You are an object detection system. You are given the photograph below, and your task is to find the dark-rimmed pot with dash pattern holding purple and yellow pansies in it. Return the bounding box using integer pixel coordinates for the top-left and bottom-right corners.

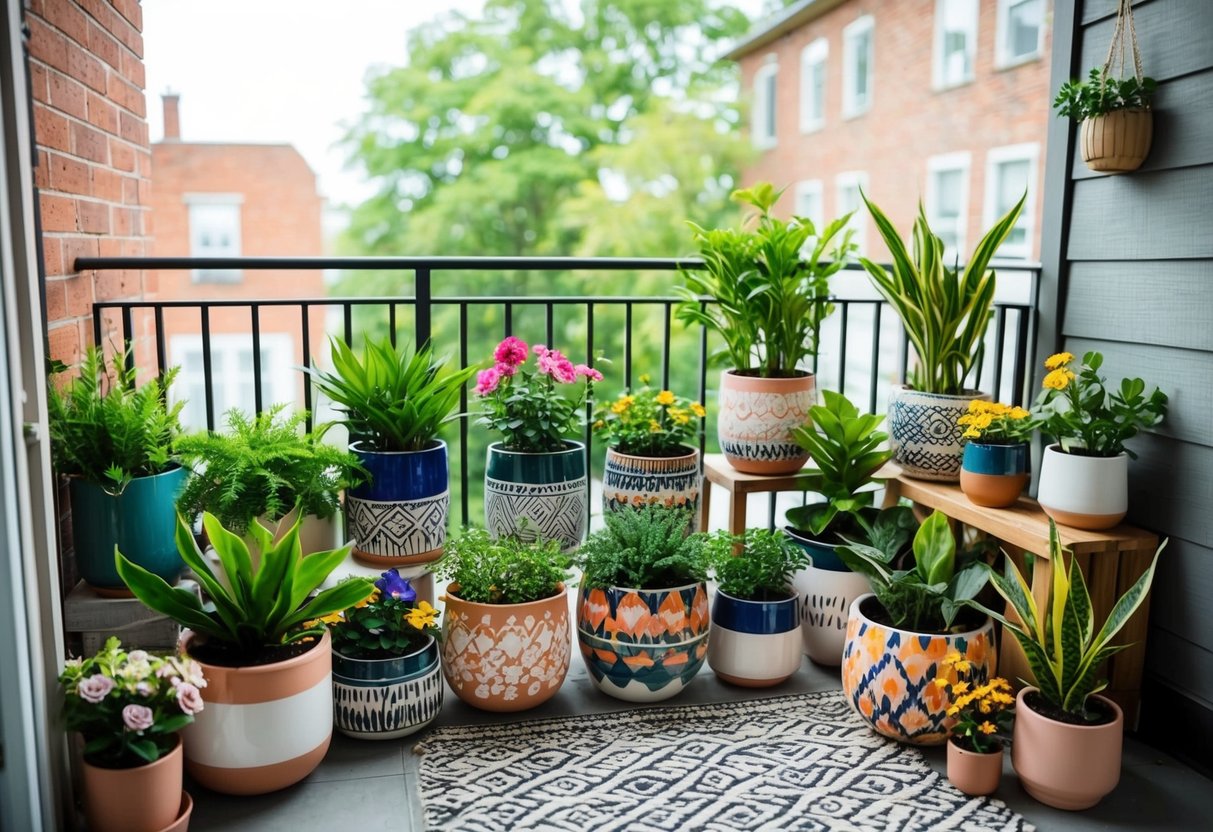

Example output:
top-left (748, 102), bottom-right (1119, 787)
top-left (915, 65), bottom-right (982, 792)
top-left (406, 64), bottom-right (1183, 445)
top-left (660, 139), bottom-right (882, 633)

top-left (332, 638), bottom-right (445, 740)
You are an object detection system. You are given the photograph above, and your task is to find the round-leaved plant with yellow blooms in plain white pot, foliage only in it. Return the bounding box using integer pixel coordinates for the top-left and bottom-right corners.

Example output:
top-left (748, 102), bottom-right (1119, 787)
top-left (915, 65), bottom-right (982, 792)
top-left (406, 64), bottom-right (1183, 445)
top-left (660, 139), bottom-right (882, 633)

top-left (1032, 352), bottom-right (1167, 460)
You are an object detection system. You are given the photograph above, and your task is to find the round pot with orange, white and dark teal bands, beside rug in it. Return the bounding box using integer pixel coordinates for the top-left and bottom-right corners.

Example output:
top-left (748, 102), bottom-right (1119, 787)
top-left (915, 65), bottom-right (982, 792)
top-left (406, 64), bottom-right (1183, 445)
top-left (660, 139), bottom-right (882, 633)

top-left (577, 582), bottom-right (711, 702)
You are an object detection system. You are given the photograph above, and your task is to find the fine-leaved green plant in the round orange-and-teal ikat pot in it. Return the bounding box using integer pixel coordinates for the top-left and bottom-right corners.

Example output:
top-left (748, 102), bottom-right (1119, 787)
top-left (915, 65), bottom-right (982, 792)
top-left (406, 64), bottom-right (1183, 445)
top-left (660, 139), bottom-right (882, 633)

top-left (576, 503), bottom-right (707, 589)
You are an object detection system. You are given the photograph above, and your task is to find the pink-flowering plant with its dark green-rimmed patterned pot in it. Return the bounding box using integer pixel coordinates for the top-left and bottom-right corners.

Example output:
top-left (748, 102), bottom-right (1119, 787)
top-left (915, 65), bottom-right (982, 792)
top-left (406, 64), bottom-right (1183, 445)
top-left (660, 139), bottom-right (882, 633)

top-left (475, 336), bottom-right (603, 552)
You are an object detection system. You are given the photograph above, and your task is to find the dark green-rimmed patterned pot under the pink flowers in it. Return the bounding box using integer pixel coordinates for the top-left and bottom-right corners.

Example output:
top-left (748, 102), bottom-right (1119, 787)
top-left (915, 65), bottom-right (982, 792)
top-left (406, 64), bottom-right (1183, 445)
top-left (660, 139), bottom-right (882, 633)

top-left (484, 440), bottom-right (590, 552)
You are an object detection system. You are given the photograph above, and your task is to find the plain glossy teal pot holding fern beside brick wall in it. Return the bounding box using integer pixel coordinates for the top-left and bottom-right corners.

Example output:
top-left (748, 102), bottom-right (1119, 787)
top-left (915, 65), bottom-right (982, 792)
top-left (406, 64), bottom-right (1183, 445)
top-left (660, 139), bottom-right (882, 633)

top-left (68, 466), bottom-right (188, 597)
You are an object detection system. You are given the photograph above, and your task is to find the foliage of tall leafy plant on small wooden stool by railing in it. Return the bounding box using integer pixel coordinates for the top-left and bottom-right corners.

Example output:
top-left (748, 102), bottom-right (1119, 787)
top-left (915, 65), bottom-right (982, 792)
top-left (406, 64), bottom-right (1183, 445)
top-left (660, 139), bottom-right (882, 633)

top-left (678, 182), bottom-right (855, 378)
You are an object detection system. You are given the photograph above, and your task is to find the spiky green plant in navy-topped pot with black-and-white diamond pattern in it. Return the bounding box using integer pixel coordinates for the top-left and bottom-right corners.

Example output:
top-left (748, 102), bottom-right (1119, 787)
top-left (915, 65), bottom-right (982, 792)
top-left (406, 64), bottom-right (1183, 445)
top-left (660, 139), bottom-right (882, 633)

top-left (307, 337), bottom-right (475, 571)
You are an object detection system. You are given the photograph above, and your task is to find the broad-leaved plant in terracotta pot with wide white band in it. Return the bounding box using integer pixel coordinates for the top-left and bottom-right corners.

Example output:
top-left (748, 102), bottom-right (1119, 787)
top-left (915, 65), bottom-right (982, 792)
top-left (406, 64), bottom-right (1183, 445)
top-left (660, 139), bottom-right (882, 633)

top-left (114, 513), bottom-right (374, 794)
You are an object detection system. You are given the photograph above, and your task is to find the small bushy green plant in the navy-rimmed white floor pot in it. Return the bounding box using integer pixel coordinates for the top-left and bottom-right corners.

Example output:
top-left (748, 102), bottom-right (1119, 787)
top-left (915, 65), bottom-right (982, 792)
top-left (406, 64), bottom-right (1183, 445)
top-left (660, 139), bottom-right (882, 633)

top-left (704, 529), bottom-right (809, 600)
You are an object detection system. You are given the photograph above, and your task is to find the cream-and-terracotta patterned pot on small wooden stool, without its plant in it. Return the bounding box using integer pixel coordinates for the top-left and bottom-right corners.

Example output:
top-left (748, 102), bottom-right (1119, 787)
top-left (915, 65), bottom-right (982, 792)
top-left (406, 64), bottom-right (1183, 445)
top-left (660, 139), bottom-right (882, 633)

top-left (717, 370), bottom-right (818, 474)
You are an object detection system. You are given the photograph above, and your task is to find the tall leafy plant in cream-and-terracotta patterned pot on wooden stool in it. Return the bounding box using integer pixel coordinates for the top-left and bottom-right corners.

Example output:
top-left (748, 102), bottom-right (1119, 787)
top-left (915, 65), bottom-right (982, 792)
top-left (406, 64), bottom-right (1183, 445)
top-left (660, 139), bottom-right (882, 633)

top-left (678, 182), bottom-right (855, 474)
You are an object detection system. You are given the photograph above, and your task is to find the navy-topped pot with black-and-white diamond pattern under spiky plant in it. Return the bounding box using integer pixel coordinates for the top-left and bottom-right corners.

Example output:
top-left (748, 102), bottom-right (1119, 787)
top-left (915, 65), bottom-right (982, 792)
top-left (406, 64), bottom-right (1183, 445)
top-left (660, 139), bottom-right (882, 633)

top-left (346, 440), bottom-right (450, 568)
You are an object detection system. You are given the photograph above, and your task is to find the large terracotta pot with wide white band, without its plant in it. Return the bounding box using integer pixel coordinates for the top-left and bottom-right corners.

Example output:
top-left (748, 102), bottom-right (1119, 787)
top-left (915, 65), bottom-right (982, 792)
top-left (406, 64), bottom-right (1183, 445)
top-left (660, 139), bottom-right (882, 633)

top-left (182, 631), bottom-right (332, 794)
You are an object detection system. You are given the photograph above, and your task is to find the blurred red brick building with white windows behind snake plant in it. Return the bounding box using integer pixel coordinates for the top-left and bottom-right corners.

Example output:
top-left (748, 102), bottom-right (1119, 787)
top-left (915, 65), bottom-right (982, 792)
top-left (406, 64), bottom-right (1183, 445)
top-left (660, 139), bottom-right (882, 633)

top-left (728, 0), bottom-right (1053, 261)
